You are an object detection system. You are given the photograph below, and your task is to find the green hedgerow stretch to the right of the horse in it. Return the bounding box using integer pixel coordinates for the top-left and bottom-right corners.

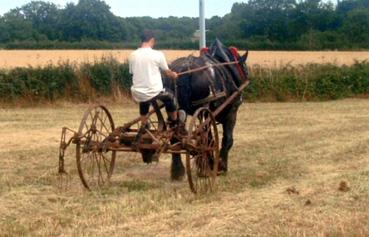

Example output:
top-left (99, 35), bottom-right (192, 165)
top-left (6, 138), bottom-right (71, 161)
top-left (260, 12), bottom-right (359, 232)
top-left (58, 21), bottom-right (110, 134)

top-left (244, 62), bottom-right (369, 101)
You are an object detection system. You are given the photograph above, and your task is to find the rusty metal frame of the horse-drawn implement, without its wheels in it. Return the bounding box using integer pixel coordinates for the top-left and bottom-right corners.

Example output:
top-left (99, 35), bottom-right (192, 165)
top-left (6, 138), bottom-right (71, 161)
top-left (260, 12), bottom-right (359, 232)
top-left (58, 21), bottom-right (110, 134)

top-left (58, 57), bottom-right (249, 193)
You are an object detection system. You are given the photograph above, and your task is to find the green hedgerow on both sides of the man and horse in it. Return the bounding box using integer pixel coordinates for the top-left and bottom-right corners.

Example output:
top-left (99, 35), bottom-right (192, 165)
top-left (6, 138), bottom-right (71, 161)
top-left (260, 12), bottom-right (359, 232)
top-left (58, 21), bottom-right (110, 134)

top-left (0, 58), bottom-right (369, 103)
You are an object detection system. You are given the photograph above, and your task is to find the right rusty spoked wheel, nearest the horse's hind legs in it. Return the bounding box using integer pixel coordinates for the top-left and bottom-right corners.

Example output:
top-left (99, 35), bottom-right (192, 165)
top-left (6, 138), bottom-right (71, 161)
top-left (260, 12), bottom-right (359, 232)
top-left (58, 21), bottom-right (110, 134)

top-left (186, 108), bottom-right (219, 193)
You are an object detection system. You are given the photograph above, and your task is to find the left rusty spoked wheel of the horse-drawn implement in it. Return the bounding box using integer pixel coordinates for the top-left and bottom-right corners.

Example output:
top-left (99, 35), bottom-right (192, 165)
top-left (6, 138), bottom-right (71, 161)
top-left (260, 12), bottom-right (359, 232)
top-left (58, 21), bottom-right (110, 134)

top-left (76, 106), bottom-right (116, 191)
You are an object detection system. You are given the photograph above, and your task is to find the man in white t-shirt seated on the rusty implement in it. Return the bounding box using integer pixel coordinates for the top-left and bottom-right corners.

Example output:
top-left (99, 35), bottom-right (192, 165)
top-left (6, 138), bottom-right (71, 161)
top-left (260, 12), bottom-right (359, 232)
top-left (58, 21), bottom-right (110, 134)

top-left (129, 30), bottom-right (178, 128)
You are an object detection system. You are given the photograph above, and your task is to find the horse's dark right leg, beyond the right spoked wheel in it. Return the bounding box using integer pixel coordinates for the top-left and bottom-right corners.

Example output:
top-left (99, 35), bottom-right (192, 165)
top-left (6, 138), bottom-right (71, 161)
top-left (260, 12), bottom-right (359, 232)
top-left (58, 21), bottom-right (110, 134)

top-left (220, 105), bottom-right (239, 173)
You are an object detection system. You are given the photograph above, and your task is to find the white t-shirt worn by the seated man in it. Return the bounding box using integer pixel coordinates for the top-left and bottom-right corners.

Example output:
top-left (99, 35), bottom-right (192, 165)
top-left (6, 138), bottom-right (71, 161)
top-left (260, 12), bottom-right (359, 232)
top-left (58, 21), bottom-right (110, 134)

top-left (129, 48), bottom-right (169, 102)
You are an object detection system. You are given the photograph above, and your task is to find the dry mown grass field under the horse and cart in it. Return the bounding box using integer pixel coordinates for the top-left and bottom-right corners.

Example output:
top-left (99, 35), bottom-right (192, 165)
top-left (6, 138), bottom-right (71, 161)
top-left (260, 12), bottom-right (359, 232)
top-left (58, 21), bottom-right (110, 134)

top-left (0, 100), bottom-right (369, 236)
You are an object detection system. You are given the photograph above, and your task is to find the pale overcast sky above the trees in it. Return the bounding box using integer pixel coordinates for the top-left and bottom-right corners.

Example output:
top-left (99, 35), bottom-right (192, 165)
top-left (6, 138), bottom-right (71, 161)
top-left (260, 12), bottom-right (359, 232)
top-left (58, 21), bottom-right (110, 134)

top-left (0, 0), bottom-right (246, 18)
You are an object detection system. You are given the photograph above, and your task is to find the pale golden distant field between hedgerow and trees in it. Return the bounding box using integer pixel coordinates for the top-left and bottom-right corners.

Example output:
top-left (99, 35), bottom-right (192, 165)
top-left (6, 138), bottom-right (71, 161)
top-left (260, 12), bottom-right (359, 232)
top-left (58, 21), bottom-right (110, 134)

top-left (0, 50), bottom-right (369, 68)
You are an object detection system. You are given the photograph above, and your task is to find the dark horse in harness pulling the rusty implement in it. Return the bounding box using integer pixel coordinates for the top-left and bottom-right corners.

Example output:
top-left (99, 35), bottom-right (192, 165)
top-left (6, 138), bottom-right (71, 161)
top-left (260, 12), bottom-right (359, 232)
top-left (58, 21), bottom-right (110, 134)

top-left (163, 39), bottom-right (249, 180)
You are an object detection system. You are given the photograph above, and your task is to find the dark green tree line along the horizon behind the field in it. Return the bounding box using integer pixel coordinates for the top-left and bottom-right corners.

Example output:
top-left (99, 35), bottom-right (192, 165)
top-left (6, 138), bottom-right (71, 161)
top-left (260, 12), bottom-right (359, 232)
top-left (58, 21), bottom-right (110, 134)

top-left (0, 0), bottom-right (369, 50)
